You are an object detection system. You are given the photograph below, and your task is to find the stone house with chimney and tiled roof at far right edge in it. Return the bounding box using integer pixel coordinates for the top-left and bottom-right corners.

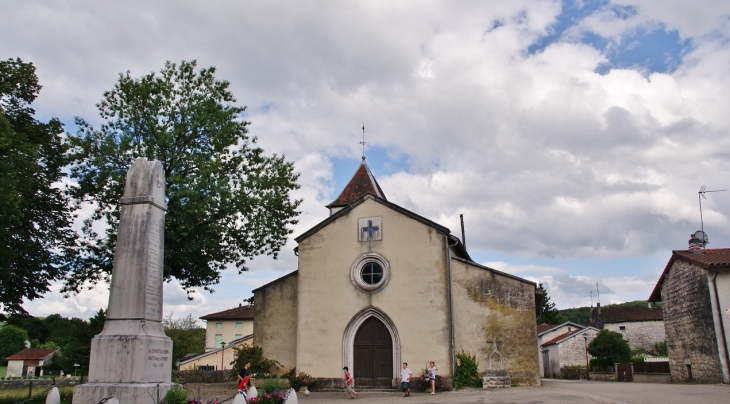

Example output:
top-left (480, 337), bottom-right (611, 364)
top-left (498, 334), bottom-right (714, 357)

top-left (649, 246), bottom-right (730, 383)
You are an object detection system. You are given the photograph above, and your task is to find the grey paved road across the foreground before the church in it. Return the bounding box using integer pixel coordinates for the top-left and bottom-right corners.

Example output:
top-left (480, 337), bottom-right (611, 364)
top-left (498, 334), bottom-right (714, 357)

top-left (286, 380), bottom-right (730, 404)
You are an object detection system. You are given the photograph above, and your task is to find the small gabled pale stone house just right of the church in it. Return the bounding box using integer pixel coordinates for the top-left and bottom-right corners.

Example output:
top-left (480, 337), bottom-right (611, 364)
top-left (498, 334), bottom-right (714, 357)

top-left (540, 323), bottom-right (599, 378)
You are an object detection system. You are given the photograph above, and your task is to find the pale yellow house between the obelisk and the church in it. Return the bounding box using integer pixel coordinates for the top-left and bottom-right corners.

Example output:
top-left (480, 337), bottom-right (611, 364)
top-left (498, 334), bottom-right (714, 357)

top-left (200, 304), bottom-right (254, 352)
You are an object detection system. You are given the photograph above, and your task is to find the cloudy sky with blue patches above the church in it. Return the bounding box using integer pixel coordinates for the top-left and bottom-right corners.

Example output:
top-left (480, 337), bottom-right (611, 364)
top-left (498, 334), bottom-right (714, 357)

top-left (0, 0), bottom-right (730, 318)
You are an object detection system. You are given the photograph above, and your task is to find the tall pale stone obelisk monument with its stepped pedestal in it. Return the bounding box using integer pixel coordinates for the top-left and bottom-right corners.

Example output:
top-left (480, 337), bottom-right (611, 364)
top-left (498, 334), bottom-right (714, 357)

top-left (73, 158), bottom-right (172, 404)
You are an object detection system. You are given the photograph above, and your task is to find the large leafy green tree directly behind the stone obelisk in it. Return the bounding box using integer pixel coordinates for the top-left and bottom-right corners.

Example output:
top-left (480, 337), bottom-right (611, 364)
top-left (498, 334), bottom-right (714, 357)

top-left (64, 61), bottom-right (301, 292)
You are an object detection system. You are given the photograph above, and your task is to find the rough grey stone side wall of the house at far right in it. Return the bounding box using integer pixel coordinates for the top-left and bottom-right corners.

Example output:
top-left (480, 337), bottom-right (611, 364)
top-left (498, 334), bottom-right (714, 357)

top-left (662, 260), bottom-right (721, 383)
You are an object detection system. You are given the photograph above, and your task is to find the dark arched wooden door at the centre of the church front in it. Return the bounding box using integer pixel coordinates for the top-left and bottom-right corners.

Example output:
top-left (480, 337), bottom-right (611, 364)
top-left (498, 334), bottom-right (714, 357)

top-left (353, 317), bottom-right (393, 387)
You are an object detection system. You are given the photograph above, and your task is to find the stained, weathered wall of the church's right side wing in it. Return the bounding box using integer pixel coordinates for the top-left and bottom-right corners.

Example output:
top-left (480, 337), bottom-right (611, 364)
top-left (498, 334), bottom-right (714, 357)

top-left (452, 258), bottom-right (540, 386)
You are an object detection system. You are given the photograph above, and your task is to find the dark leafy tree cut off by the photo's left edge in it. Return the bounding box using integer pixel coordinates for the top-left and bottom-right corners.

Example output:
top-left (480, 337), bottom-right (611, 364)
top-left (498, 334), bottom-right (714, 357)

top-left (0, 59), bottom-right (76, 313)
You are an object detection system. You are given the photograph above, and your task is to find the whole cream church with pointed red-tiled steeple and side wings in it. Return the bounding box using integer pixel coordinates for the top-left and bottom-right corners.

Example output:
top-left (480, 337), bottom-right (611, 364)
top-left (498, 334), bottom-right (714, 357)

top-left (254, 159), bottom-right (542, 388)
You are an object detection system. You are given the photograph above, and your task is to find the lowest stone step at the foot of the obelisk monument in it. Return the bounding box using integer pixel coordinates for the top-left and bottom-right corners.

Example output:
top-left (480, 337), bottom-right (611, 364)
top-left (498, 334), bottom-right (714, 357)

top-left (73, 383), bottom-right (175, 404)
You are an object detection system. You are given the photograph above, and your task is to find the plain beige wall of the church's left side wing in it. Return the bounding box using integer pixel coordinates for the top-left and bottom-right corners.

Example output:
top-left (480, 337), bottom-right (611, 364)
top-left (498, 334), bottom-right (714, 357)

top-left (253, 274), bottom-right (298, 373)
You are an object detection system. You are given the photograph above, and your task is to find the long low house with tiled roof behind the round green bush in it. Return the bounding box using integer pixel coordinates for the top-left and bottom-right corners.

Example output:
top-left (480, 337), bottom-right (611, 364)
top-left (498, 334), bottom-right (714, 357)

top-left (591, 303), bottom-right (666, 352)
